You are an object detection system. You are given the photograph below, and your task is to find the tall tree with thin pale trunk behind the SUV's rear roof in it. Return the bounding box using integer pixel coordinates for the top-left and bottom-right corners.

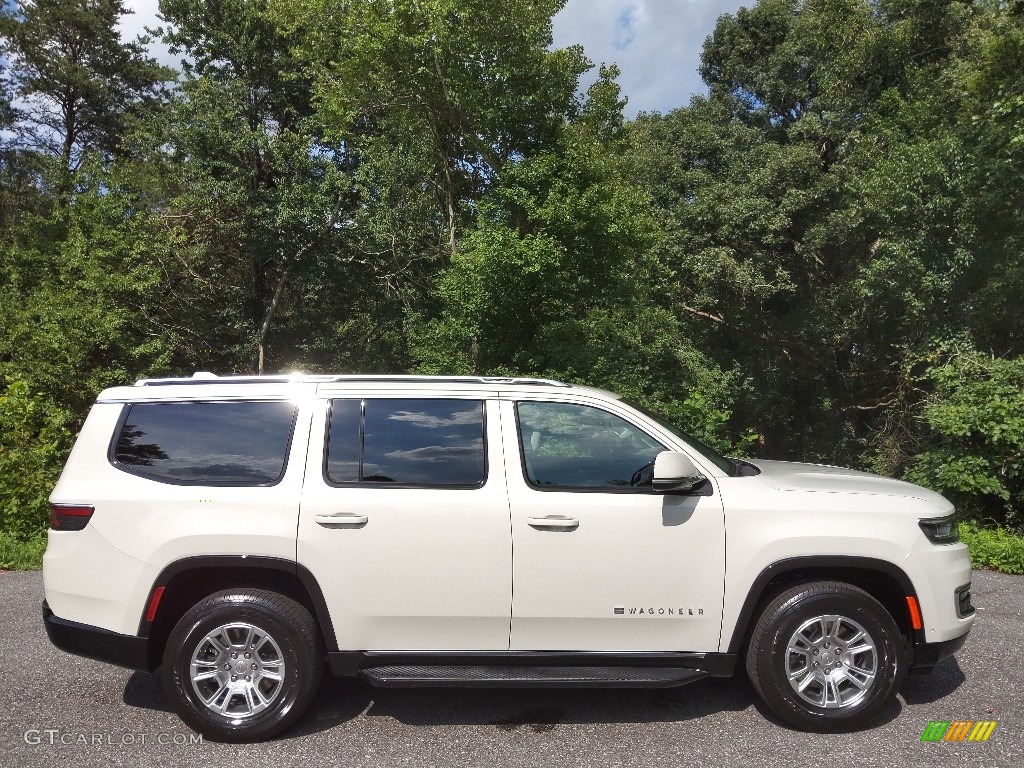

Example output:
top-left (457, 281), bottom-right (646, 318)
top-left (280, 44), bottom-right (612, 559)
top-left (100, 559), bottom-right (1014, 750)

top-left (147, 0), bottom-right (400, 373)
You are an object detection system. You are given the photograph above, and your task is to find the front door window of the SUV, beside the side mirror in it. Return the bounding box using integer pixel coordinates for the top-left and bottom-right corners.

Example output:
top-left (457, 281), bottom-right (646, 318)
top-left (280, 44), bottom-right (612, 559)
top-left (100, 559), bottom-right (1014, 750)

top-left (516, 401), bottom-right (666, 490)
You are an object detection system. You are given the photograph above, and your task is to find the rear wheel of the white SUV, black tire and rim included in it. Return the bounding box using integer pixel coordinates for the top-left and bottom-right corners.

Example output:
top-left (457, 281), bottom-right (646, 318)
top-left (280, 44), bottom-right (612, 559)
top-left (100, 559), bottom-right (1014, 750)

top-left (162, 589), bottom-right (324, 741)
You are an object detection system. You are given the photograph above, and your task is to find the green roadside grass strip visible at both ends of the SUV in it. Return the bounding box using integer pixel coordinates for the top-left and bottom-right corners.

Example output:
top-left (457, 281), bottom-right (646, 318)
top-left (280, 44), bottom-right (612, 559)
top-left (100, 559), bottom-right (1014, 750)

top-left (0, 522), bottom-right (1024, 573)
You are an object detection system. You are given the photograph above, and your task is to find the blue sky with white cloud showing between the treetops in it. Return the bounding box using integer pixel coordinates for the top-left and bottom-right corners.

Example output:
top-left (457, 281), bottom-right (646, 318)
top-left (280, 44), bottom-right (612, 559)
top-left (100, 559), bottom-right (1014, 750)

top-left (122, 0), bottom-right (754, 118)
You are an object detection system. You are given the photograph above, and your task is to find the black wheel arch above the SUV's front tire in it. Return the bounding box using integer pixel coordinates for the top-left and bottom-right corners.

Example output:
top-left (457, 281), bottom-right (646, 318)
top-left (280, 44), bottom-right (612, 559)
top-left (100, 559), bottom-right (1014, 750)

top-left (728, 555), bottom-right (925, 653)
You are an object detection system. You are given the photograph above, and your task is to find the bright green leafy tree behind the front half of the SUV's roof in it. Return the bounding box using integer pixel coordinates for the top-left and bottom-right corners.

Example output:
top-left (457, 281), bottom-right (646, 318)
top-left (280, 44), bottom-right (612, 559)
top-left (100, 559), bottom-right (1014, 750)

top-left (413, 69), bottom-right (736, 446)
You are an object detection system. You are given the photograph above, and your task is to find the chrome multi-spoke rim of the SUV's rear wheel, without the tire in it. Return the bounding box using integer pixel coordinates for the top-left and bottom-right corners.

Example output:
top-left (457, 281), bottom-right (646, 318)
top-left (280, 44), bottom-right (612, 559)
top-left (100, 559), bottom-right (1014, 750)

top-left (188, 622), bottom-right (285, 720)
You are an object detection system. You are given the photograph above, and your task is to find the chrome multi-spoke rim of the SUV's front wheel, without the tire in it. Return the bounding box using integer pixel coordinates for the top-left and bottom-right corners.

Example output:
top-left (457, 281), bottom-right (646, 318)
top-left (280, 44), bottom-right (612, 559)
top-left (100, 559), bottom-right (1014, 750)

top-left (785, 614), bottom-right (879, 710)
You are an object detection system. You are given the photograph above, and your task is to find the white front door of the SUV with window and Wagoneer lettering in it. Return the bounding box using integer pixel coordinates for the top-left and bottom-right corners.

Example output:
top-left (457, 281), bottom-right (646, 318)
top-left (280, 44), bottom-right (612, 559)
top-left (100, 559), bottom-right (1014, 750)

top-left (501, 397), bottom-right (725, 651)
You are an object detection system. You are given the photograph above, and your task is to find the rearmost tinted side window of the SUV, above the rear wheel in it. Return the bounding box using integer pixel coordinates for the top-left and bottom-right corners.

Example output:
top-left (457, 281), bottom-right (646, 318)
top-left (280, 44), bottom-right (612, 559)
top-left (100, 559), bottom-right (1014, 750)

top-left (111, 401), bottom-right (296, 486)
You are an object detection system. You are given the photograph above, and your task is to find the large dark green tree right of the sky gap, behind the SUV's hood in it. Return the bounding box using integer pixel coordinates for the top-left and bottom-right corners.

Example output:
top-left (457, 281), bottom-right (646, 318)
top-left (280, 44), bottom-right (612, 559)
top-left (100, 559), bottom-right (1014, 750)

top-left (632, 0), bottom-right (976, 462)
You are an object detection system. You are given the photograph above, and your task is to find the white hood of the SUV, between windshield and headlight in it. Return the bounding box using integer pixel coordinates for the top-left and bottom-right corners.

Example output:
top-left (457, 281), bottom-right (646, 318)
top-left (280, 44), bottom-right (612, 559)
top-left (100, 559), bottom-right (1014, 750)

top-left (744, 459), bottom-right (952, 510)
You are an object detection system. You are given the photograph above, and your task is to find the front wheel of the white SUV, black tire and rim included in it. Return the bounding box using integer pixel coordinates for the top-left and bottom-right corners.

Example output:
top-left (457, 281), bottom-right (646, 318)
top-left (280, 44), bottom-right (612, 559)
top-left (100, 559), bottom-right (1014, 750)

top-left (746, 582), bottom-right (906, 732)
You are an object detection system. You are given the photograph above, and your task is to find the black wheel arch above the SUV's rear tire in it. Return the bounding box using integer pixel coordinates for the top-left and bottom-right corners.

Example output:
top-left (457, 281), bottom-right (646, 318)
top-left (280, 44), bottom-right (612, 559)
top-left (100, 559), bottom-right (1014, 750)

top-left (138, 555), bottom-right (338, 671)
